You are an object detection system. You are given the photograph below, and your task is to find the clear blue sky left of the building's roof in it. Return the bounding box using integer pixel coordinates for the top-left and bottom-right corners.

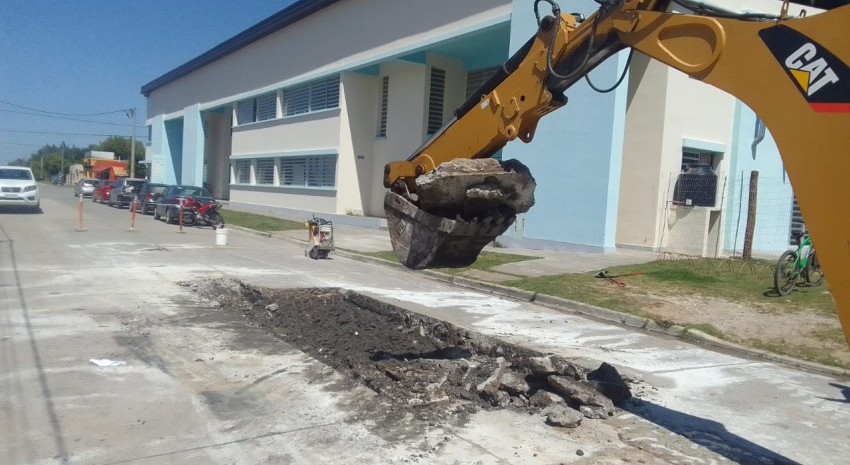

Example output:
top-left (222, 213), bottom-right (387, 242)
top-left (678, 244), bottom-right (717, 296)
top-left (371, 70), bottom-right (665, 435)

top-left (0, 0), bottom-right (294, 164)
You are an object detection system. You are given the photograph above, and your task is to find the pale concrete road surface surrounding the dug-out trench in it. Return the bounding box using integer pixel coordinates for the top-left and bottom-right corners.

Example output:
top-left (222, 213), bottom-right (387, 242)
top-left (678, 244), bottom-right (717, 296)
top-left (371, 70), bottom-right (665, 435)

top-left (0, 186), bottom-right (850, 465)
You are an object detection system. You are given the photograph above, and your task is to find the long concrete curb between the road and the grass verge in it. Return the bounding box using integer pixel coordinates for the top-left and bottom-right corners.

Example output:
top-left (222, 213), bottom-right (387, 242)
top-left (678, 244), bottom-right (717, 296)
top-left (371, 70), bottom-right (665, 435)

top-left (229, 226), bottom-right (850, 377)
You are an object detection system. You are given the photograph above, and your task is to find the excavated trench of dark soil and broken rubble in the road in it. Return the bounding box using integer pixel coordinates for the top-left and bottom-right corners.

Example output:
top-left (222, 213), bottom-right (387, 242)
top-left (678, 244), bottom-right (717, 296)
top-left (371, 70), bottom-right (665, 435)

top-left (182, 279), bottom-right (631, 427)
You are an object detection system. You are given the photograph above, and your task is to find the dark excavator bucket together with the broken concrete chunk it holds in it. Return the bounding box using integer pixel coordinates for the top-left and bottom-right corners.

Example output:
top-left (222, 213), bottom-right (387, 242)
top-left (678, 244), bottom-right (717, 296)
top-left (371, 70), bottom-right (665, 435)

top-left (384, 158), bottom-right (536, 269)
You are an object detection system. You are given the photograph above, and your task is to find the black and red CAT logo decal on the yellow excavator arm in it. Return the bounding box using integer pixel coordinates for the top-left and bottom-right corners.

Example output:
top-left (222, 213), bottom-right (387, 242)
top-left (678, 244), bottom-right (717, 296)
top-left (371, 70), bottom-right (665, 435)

top-left (759, 25), bottom-right (850, 113)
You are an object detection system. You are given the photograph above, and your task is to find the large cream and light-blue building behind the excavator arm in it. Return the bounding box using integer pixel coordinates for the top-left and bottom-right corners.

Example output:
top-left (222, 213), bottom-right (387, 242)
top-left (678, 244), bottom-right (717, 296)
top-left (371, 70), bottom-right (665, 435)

top-left (141, 0), bottom-right (811, 256)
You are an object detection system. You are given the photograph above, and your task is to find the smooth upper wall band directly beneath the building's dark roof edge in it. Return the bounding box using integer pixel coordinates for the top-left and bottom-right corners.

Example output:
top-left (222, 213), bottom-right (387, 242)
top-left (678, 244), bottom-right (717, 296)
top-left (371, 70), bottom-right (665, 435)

top-left (147, 0), bottom-right (510, 115)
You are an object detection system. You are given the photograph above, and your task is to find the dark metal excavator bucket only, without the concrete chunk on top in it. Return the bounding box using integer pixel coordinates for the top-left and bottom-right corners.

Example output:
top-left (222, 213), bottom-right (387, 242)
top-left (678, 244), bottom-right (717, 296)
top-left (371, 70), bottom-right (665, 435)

top-left (384, 192), bottom-right (516, 270)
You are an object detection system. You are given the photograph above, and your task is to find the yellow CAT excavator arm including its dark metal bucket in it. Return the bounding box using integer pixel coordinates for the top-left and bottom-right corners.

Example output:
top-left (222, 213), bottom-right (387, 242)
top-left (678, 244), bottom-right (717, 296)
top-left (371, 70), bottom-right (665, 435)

top-left (384, 0), bottom-right (850, 342)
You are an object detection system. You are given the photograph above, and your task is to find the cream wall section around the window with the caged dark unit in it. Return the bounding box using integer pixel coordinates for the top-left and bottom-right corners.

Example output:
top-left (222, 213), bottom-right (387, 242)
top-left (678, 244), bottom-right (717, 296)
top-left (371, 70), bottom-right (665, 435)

top-left (617, 0), bottom-right (817, 255)
